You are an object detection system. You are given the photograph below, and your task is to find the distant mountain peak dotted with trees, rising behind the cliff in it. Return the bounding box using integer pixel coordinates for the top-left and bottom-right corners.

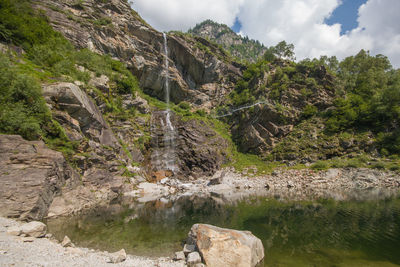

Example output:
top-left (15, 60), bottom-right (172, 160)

top-left (188, 20), bottom-right (267, 63)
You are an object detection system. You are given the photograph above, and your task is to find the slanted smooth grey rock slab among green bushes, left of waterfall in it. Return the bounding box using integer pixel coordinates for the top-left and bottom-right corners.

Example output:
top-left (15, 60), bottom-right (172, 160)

top-left (43, 83), bottom-right (119, 147)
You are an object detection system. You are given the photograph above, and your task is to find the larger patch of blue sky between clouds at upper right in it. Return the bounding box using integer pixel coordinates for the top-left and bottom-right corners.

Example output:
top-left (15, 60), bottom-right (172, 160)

top-left (325, 0), bottom-right (367, 35)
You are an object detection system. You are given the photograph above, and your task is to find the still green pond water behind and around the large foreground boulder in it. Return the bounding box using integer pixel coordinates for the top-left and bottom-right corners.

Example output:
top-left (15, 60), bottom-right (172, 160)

top-left (48, 196), bottom-right (400, 266)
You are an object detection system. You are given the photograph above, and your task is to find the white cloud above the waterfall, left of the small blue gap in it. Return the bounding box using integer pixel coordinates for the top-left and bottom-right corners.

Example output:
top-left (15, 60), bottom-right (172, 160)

top-left (132, 0), bottom-right (245, 31)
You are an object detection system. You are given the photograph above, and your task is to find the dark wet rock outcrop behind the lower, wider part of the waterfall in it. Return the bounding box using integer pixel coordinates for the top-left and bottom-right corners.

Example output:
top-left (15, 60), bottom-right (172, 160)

top-left (149, 111), bottom-right (229, 180)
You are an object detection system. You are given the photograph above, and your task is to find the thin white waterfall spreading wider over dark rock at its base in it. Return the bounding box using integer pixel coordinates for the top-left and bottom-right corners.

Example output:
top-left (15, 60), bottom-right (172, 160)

top-left (151, 33), bottom-right (178, 174)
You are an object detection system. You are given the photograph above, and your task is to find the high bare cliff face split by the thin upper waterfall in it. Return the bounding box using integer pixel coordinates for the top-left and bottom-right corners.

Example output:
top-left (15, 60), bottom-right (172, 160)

top-left (34, 0), bottom-right (241, 107)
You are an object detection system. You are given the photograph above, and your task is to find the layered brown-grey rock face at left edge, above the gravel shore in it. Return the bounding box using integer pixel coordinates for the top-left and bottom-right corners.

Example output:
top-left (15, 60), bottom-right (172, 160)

top-left (0, 135), bottom-right (79, 220)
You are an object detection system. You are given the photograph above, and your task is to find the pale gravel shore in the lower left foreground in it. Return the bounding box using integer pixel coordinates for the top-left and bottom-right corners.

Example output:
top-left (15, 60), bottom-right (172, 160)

top-left (0, 217), bottom-right (185, 267)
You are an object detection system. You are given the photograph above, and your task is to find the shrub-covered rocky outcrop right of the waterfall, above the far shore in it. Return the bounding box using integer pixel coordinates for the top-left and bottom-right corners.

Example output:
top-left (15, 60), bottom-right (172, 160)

top-left (230, 63), bottom-right (335, 156)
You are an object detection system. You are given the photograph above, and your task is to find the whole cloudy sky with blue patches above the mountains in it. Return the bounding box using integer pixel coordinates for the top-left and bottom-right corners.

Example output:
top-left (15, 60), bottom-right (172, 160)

top-left (132, 0), bottom-right (400, 68)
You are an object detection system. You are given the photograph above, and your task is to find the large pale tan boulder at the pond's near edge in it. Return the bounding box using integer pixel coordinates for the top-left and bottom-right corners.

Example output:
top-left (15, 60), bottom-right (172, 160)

top-left (188, 224), bottom-right (264, 267)
